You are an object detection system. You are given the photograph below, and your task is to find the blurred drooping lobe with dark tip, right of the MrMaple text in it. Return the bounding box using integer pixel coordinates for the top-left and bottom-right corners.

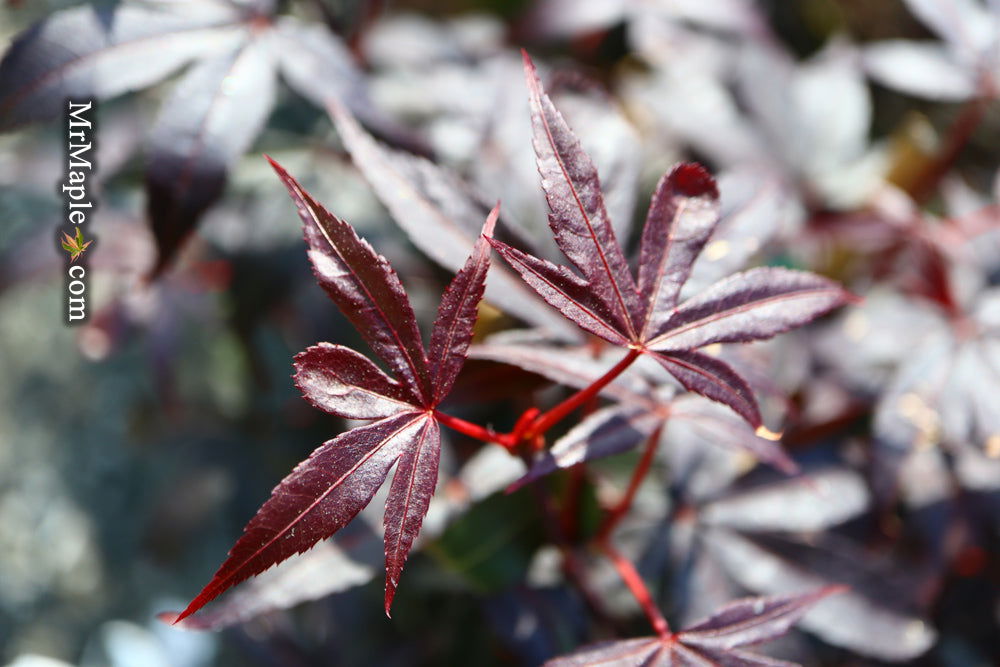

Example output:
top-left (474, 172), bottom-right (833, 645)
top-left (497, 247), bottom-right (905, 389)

top-left (146, 38), bottom-right (275, 275)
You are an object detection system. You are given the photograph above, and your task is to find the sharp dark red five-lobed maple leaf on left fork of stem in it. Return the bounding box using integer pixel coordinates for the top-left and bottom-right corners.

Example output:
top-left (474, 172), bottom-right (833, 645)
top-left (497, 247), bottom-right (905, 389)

top-left (175, 160), bottom-right (499, 622)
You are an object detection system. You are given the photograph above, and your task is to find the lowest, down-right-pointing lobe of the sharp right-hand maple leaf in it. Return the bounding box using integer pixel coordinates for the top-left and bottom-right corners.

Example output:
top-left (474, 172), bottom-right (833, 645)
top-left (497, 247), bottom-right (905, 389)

top-left (650, 351), bottom-right (762, 428)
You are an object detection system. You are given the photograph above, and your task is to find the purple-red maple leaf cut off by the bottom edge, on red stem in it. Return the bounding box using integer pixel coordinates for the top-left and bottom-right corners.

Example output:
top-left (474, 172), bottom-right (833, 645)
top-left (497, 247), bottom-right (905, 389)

top-left (545, 586), bottom-right (844, 667)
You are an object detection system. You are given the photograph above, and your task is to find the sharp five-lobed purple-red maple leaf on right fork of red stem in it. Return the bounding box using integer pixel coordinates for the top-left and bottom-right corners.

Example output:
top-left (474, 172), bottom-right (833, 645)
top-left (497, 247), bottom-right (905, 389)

top-left (490, 53), bottom-right (849, 428)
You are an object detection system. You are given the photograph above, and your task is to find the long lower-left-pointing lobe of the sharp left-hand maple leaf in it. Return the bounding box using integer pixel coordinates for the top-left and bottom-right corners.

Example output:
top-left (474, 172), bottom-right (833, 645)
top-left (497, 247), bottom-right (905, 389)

top-left (176, 412), bottom-right (427, 621)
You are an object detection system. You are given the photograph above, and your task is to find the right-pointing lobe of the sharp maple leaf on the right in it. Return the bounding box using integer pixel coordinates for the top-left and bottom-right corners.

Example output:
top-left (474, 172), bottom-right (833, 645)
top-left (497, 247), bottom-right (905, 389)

top-left (648, 267), bottom-right (850, 351)
